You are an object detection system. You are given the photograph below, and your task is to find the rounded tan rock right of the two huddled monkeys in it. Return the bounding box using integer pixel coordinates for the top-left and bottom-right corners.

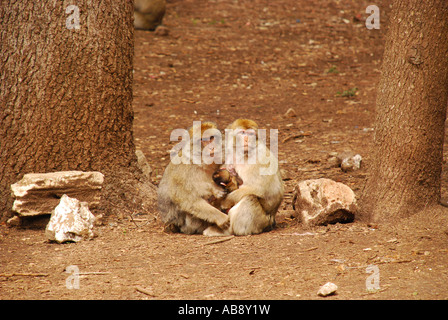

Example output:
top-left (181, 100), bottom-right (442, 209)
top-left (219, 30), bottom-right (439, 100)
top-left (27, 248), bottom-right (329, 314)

top-left (292, 178), bottom-right (357, 226)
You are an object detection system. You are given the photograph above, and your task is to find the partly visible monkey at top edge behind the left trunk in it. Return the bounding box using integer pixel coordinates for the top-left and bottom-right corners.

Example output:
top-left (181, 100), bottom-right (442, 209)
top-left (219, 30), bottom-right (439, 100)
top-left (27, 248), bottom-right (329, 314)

top-left (134, 0), bottom-right (166, 31)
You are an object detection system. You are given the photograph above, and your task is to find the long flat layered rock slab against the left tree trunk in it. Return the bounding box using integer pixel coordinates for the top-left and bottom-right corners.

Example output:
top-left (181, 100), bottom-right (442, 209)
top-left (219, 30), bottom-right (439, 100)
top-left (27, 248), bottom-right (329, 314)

top-left (11, 171), bottom-right (104, 216)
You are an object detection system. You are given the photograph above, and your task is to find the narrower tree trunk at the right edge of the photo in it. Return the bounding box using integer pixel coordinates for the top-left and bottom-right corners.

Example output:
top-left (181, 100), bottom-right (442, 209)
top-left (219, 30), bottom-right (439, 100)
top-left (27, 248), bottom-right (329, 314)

top-left (360, 0), bottom-right (448, 222)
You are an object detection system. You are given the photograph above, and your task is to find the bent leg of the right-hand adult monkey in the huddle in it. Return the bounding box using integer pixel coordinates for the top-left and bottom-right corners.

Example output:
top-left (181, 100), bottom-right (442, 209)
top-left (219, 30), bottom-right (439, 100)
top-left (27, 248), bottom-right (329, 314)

top-left (229, 195), bottom-right (274, 236)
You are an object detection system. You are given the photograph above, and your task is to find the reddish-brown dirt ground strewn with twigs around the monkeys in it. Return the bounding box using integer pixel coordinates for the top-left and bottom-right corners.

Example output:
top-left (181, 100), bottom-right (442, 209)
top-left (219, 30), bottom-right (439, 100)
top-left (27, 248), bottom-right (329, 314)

top-left (0, 0), bottom-right (448, 300)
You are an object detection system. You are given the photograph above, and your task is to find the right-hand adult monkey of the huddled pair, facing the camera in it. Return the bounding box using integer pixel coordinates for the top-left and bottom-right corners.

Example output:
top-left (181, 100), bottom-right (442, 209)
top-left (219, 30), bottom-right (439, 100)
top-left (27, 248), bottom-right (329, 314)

top-left (206, 119), bottom-right (284, 236)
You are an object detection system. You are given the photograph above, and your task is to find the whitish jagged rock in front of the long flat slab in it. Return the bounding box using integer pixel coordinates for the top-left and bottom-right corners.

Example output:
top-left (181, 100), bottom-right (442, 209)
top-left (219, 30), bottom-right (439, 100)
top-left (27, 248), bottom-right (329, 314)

top-left (45, 194), bottom-right (95, 243)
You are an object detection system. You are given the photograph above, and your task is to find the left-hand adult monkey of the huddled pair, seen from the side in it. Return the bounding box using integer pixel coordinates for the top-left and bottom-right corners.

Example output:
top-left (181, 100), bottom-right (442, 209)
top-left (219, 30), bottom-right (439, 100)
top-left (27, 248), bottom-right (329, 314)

top-left (157, 122), bottom-right (229, 234)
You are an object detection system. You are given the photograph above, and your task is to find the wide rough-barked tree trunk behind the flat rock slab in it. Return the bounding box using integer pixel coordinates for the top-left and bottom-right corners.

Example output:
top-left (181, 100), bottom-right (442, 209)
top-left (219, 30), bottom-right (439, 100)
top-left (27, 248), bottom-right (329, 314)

top-left (0, 0), bottom-right (158, 220)
